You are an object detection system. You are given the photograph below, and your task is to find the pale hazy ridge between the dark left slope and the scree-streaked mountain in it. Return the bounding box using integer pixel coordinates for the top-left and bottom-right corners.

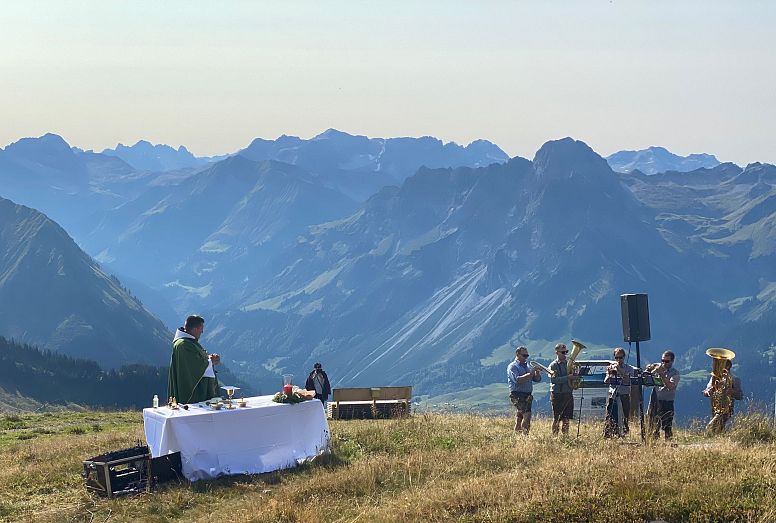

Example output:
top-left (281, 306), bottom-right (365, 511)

top-left (84, 155), bottom-right (356, 314)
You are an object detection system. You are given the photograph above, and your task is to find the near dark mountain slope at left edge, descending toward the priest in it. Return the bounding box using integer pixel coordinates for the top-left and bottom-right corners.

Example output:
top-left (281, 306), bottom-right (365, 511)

top-left (0, 198), bottom-right (170, 367)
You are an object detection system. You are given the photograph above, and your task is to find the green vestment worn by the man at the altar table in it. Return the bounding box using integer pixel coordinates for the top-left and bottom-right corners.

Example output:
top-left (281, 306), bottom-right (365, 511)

top-left (167, 338), bottom-right (218, 403)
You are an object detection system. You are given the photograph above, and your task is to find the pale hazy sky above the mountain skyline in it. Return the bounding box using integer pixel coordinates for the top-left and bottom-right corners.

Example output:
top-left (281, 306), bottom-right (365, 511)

top-left (0, 0), bottom-right (776, 164)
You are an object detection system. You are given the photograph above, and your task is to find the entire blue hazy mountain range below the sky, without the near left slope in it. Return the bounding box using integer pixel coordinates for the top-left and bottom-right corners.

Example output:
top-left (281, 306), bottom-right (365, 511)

top-left (0, 130), bottom-right (776, 416)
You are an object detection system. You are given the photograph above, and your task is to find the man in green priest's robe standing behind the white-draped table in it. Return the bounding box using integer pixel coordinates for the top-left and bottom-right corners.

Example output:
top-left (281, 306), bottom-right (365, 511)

top-left (167, 315), bottom-right (221, 403)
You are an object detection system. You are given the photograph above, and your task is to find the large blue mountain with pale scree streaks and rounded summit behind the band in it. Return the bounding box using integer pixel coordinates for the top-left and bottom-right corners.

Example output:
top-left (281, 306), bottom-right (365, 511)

top-left (203, 139), bottom-right (744, 398)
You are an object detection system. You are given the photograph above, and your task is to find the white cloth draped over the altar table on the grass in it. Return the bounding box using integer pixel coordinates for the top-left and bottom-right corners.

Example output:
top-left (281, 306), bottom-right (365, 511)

top-left (143, 396), bottom-right (329, 481)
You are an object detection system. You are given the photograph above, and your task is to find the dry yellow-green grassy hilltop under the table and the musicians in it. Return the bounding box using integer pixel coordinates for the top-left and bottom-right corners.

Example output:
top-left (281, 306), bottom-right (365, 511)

top-left (0, 412), bottom-right (776, 522)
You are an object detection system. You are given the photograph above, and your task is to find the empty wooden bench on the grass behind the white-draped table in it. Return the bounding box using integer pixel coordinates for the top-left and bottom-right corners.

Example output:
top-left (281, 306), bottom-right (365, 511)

top-left (327, 387), bottom-right (412, 419)
